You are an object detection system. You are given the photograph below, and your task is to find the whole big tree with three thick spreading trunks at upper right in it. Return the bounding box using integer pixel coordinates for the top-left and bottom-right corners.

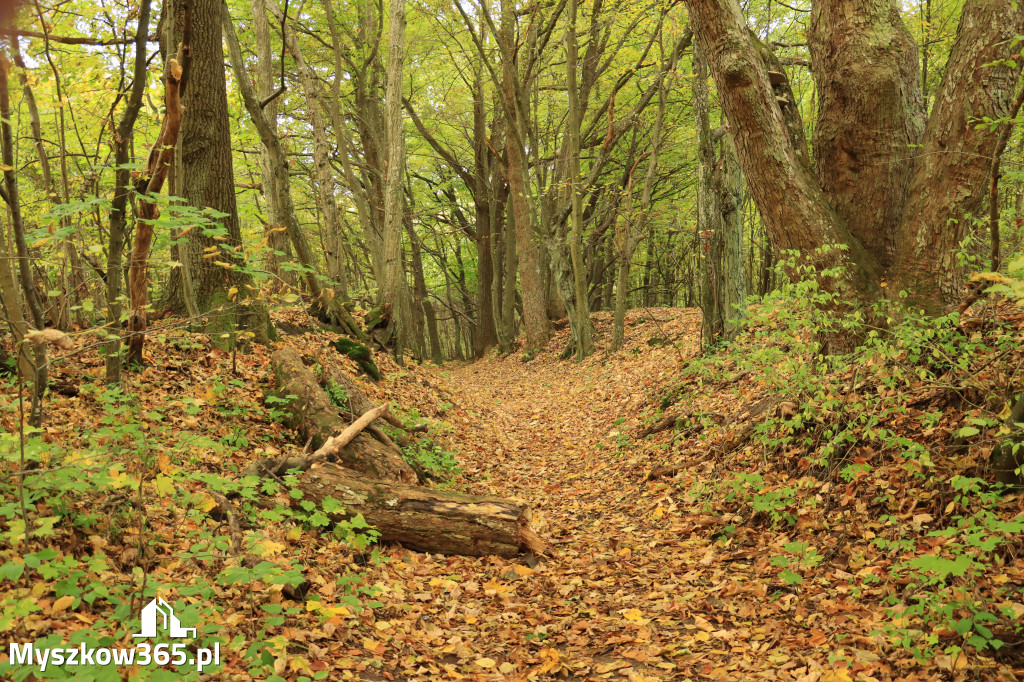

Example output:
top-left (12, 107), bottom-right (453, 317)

top-left (686, 0), bottom-right (1024, 311)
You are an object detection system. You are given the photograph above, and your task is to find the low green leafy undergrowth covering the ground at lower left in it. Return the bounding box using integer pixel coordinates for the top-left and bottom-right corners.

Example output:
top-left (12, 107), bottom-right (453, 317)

top-left (0, 348), bottom-right (378, 680)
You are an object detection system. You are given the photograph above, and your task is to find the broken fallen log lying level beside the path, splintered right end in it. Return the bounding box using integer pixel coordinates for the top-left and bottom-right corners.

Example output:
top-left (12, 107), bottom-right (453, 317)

top-left (294, 464), bottom-right (545, 558)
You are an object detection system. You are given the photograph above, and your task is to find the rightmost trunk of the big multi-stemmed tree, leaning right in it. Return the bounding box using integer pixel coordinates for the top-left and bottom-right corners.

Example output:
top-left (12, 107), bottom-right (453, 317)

top-left (892, 0), bottom-right (1024, 303)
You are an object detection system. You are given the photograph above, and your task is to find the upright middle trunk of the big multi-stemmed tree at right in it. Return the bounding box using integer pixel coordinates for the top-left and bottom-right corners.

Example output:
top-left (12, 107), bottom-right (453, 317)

top-left (807, 0), bottom-right (925, 267)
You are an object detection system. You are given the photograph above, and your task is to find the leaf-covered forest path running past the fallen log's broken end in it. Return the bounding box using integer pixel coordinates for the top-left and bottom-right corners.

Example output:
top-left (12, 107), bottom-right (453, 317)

top-left (419, 309), bottom-right (787, 680)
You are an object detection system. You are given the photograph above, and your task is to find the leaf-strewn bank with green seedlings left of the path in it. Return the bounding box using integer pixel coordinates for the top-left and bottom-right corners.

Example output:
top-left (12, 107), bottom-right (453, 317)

top-left (0, 310), bottom-right (464, 680)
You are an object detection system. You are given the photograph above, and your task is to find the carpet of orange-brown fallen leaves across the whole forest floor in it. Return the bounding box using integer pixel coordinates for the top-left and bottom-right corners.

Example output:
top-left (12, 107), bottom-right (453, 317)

top-left (0, 308), bottom-right (1024, 682)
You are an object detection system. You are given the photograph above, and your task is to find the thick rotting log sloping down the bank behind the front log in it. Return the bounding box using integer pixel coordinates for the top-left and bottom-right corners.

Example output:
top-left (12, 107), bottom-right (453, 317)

top-left (270, 348), bottom-right (418, 483)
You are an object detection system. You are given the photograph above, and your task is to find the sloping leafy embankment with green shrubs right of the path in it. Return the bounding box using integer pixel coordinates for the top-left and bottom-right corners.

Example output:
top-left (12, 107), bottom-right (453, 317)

top-left (638, 291), bottom-right (1024, 671)
